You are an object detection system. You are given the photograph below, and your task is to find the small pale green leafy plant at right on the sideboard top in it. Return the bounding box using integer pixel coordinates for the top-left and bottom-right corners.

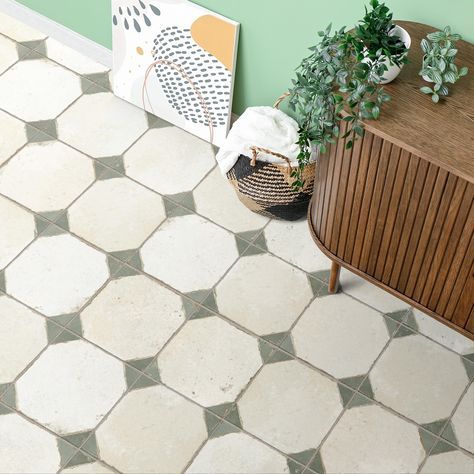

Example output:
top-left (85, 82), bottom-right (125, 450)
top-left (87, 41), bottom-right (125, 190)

top-left (420, 26), bottom-right (468, 103)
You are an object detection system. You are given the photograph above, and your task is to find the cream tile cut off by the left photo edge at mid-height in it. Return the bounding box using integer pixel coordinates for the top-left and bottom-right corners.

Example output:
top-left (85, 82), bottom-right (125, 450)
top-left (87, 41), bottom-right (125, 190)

top-left (0, 196), bottom-right (35, 269)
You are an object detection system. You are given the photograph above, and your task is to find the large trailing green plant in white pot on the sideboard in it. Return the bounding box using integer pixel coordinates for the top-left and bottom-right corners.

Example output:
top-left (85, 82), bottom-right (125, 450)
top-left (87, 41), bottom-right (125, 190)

top-left (289, 0), bottom-right (410, 188)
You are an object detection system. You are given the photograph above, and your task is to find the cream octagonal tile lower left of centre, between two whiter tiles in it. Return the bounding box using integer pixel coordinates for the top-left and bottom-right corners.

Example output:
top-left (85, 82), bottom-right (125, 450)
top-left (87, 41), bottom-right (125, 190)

top-left (81, 275), bottom-right (184, 360)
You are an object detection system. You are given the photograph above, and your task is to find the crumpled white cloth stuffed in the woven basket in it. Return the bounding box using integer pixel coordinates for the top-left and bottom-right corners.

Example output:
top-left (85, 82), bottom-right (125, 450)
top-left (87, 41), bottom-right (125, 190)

top-left (216, 107), bottom-right (299, 174)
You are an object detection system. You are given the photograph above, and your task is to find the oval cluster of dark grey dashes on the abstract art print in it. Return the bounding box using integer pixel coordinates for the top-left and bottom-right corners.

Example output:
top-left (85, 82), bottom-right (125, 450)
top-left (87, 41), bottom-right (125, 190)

top-left (153, 26), bottom-right (232, 127)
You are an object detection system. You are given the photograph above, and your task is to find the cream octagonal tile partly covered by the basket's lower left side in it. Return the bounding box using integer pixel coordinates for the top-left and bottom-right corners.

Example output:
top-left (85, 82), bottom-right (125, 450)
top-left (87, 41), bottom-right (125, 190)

top-left (193, 167), bottom-right (269, 232)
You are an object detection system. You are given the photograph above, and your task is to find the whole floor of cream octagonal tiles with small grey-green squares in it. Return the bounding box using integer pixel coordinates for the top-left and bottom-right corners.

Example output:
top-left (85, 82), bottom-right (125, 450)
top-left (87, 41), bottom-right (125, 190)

top-left (0, 15), bottom-right (474, 474)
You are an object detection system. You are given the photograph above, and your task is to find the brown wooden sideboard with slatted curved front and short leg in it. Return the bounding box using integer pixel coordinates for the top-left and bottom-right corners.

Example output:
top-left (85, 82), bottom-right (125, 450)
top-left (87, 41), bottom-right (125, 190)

top-left (308, 22), bottom-right (474, 339)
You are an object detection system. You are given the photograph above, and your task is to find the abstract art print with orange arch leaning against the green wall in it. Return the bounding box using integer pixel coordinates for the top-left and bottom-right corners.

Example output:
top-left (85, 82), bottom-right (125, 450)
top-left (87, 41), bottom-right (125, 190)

top-left (112, 0), bottom-right (239, 146)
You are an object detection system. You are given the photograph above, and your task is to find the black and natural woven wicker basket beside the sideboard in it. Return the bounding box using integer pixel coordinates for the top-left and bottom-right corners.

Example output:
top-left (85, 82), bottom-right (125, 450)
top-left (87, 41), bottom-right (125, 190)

top-left (227, 94), bottom-right (316, 221)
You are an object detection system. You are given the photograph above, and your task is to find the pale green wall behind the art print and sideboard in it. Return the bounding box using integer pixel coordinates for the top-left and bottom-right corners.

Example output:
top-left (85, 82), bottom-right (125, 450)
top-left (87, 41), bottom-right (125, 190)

top-left (14, 0), bottom-right (474, 113)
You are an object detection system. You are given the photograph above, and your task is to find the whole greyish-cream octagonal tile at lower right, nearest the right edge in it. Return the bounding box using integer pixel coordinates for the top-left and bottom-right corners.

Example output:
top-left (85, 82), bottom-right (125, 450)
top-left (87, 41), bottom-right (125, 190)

top-left (370, 335), bottom-right (469, 423)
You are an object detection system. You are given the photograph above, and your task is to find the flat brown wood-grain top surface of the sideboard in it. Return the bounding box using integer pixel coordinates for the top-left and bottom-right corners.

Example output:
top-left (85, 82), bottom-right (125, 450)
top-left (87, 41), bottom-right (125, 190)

top-left (366, 21), bottom-right (474, 183)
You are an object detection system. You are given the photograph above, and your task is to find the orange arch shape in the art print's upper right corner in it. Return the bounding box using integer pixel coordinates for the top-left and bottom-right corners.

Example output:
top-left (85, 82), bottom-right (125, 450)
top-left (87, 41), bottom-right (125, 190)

top-left (191, 15), bottom-right (236, 71)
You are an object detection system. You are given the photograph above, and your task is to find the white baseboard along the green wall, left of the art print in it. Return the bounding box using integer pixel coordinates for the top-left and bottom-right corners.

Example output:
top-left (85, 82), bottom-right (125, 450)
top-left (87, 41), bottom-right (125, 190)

top-left (0, 0), bottom-right (112, 68)
